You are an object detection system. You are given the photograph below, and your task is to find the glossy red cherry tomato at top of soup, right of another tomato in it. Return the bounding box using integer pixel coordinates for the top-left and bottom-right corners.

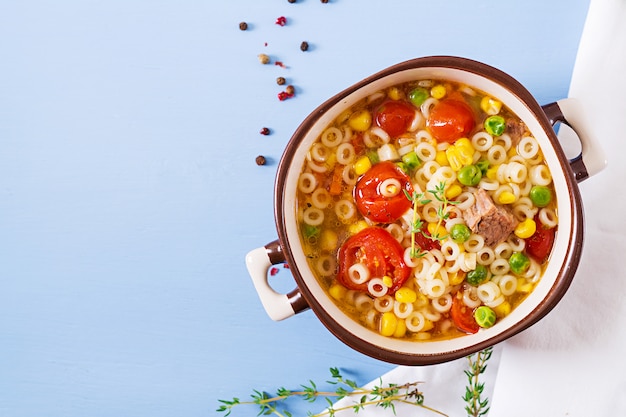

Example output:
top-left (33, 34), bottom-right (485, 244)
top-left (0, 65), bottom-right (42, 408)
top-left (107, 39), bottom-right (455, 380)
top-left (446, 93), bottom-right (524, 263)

top-left (426, 99), bottom-right (476, 143)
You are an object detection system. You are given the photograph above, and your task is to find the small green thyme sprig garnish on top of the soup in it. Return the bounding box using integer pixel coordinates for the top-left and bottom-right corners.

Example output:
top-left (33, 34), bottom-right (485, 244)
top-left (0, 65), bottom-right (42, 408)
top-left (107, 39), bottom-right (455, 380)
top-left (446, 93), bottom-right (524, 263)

top-left (403, 181), bottom-right (458, 258)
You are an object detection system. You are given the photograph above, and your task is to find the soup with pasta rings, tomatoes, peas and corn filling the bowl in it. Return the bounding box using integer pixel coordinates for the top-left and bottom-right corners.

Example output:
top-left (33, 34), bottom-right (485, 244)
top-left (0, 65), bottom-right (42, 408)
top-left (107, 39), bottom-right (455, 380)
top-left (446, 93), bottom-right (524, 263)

top-left (297, 80), bottom-right (558, 341)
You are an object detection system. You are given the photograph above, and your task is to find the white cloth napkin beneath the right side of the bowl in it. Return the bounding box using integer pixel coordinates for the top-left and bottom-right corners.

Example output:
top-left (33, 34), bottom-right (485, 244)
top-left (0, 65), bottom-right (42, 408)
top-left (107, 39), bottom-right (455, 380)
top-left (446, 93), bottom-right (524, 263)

top-left (490, 0), bottom-right (626, 417)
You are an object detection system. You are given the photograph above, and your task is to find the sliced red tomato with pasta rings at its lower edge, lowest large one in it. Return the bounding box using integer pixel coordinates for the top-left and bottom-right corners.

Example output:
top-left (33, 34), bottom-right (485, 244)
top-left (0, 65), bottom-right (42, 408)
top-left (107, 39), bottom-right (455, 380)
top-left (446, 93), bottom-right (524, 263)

top-left (337, 227), bottom-right (411, 294)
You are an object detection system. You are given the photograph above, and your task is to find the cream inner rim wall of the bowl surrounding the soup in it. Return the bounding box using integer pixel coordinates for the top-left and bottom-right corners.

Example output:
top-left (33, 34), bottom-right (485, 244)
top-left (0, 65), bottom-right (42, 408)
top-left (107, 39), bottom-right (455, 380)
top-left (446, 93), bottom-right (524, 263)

top-left (282, 67), bottom-right (573, 355)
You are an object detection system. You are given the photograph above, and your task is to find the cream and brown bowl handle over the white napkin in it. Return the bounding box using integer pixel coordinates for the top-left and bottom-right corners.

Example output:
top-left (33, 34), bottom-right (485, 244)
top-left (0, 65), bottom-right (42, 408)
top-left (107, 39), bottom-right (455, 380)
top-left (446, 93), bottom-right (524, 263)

top-left (542, 98), bottom-right (606, 182)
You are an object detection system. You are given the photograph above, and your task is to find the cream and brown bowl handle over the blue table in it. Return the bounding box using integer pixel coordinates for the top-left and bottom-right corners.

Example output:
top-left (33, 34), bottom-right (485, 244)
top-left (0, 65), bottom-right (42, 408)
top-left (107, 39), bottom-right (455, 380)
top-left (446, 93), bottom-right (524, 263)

top-left (246, 240), bottom-right (309, 321)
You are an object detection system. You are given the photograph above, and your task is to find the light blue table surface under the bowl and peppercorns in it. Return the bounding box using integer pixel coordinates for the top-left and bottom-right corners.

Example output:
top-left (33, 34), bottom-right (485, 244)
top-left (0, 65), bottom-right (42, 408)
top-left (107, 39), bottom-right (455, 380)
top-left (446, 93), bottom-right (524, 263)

top-left (0, 0), bottom-right (589, 417)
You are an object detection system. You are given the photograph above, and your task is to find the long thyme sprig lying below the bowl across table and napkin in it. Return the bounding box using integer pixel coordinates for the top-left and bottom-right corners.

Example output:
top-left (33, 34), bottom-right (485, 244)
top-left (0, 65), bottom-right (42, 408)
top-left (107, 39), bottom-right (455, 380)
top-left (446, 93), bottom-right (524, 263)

top-left (217, 368), bottom-right (446, 417)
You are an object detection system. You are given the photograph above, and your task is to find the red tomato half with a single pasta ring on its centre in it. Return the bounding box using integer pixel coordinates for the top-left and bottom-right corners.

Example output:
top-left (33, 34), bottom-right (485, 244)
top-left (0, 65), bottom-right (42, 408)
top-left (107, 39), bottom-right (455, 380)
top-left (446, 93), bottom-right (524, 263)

top-left (354, 161), bottom-right (413, 223)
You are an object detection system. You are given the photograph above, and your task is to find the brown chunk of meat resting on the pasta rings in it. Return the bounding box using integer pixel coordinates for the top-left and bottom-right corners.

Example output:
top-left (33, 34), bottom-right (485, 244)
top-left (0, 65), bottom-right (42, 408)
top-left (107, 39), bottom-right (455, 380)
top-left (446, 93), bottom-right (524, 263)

top-left (463, 188), bottom-right (518, 246)
